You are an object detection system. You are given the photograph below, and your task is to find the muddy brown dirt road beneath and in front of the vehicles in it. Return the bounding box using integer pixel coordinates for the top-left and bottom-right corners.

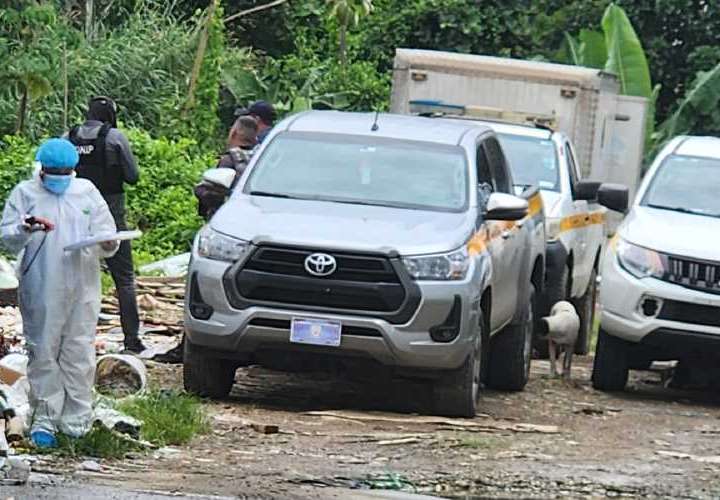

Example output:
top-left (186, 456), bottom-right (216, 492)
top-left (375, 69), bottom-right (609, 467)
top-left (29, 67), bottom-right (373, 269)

top-left (21, 358), bottom-right (720, 498)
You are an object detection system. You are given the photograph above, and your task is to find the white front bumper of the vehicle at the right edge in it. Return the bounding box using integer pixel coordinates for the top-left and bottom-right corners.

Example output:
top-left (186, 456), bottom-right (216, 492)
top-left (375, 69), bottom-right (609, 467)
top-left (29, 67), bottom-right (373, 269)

top-left (600, 251), bottom-right (720, 352)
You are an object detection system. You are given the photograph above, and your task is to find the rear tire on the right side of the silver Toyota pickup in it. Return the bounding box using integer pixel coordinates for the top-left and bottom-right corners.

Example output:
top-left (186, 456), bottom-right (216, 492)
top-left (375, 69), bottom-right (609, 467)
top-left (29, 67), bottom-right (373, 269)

top-left (488, 284), bottom-right (535, 391)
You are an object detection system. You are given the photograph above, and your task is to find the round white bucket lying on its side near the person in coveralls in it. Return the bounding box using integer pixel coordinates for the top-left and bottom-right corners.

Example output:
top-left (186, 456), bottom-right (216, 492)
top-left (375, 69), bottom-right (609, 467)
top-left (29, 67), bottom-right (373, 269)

top-left (95, 354), bottom-right (147, 398)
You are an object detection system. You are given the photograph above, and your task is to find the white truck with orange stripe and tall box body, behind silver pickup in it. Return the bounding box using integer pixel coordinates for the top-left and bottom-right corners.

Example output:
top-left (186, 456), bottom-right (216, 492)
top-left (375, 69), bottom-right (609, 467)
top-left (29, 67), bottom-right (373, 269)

top-left (391, 49), bottom-right (647, 356)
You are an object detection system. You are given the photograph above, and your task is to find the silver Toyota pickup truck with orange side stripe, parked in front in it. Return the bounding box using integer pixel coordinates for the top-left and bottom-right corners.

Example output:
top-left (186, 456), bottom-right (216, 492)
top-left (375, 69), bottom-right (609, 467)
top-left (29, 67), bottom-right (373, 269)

top-left (184, 111), bottom-right (544, 416)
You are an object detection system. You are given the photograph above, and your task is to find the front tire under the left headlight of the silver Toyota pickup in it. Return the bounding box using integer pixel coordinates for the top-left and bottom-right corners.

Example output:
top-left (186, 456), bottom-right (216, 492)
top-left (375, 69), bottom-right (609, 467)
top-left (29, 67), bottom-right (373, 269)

top-left (183, 338), bottom-right (237, 399)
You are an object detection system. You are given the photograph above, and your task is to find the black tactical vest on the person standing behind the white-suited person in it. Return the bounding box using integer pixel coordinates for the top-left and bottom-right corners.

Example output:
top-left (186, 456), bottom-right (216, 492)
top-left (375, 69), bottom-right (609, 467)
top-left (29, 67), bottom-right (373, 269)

top-left (69, 123), bottom-right (124, 195)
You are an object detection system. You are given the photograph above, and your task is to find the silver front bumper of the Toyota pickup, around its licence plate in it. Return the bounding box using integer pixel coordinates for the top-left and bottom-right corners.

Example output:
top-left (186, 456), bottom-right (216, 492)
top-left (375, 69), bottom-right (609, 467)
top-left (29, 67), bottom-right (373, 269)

top-left (185, 256), bottom-right (481, 370)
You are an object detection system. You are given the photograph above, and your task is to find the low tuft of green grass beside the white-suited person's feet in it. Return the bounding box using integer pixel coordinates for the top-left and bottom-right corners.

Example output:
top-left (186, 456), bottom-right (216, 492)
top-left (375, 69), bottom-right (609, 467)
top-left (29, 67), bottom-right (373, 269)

top-left (117, 390), bottom-right (206, 446)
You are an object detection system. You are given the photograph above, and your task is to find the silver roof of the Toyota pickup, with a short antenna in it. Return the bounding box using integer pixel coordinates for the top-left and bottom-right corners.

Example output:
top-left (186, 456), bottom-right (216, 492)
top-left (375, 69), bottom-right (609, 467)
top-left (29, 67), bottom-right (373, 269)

top-left (286, 111), bottom-right (490, 145)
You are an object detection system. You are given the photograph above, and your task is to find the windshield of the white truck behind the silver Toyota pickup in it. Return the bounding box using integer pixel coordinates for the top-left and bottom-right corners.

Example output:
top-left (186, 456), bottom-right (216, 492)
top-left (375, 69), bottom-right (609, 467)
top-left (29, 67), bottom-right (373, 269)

top-left (498, 134), bottom-right (560, 191)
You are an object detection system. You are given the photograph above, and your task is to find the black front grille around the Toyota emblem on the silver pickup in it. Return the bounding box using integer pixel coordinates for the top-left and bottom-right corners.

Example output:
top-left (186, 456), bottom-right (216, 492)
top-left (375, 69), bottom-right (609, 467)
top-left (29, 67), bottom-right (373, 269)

top-left (235, 246), bottom-right (407, 313)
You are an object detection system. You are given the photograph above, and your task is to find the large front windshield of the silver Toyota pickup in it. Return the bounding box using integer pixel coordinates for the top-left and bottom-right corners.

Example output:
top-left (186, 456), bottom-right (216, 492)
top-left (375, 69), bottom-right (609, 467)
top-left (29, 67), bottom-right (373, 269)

top-left (244, 133), bottom-right (468, 211)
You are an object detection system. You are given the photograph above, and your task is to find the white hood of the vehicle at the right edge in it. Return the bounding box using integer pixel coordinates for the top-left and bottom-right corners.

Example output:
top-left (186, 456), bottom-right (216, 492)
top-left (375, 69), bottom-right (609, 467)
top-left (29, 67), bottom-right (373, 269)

top-left (620, 206), bottom-right (720, 261)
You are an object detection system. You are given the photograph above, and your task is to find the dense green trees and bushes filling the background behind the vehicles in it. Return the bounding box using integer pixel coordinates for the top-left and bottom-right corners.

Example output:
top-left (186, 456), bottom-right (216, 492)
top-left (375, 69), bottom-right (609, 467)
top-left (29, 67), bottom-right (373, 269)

top-left (0, 0), bottom-right (720, 262)
